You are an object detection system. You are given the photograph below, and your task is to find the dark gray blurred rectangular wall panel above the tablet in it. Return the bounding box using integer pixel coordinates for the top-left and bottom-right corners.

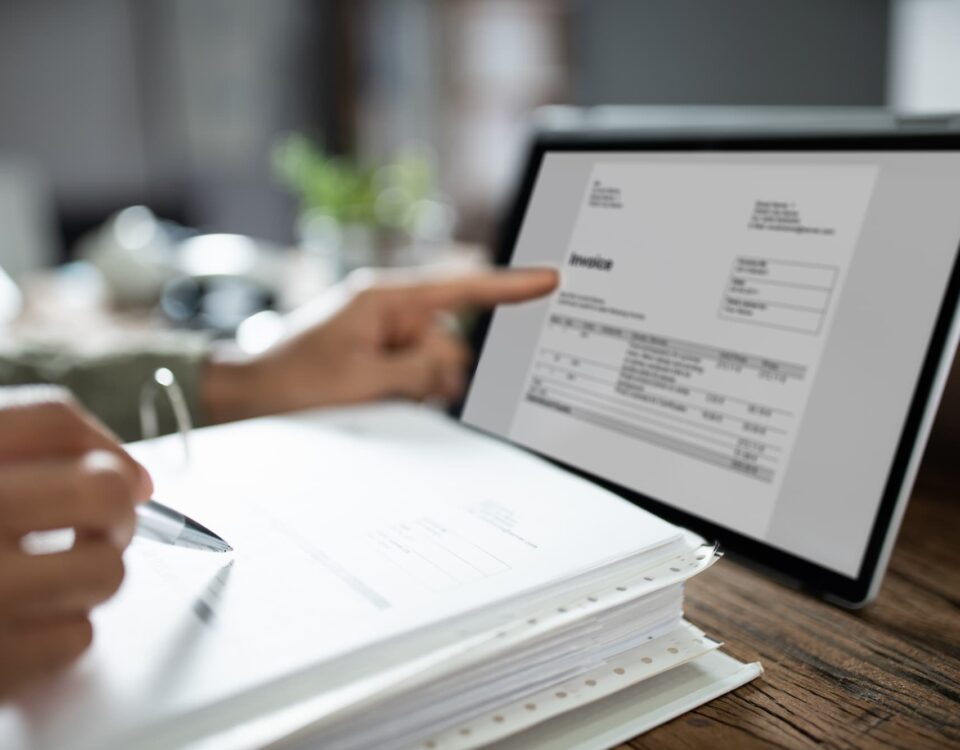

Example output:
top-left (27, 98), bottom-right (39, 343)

top-left (570, 0), bottom-right (889, 105)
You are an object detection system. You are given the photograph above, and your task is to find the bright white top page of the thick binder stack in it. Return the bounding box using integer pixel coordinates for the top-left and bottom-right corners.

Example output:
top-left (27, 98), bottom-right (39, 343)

top-left (0, 405), bottom-right (683, 748)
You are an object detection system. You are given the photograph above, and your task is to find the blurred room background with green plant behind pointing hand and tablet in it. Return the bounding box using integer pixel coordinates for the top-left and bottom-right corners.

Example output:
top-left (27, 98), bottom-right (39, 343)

top-left (0, 0), bottom-right (960, 370)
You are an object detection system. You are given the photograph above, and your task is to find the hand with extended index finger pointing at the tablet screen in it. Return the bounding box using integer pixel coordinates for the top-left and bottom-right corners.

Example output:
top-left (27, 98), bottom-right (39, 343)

top-left (204, 269), bottom-right (558, 422)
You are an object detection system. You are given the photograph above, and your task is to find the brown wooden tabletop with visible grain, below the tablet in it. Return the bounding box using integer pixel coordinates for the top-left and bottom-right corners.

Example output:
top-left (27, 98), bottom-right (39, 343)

top-left (623, 465), bottom-right (960, 750)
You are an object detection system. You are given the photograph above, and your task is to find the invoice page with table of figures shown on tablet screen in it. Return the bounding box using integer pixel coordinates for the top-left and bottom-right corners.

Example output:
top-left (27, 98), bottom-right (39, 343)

top-left (502, 161), bottom-right (878, 538)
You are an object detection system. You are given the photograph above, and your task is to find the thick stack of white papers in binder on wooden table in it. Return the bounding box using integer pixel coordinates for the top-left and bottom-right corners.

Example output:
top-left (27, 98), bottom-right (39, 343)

top-left (0, 405), bottom-right (758, 748)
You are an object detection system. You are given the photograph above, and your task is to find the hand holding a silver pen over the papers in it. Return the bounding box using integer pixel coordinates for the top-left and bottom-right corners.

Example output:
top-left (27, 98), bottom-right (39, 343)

top-left (0, 386), bottom-right (153, 699)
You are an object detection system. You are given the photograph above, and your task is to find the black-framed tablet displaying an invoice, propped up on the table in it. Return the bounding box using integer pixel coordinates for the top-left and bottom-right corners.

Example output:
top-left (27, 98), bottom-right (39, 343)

top-left (459, 133), bottom-right (960, 606)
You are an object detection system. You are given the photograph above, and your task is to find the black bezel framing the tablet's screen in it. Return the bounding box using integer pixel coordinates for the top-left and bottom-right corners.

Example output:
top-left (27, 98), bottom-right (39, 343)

top-left (453, 132), bottom-right (960, 607)
